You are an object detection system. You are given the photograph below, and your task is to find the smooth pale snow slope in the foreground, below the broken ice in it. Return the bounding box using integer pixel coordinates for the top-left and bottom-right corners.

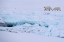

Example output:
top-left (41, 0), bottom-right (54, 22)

top-left (0, 31), bottom-right (64, 42)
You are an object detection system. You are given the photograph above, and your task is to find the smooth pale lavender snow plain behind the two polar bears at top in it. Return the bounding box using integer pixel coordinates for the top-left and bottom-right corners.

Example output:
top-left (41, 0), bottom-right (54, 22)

top-left (0, 0), bottom-right (64, 12)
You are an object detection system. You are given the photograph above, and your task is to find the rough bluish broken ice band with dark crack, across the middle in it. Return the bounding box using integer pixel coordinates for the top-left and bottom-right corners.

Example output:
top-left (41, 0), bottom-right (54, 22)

top-left (0, 11), bottom-right (64, 38)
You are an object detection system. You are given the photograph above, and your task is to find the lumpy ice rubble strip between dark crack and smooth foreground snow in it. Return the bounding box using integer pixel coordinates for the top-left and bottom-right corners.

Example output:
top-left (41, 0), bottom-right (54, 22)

top-left (0, 24), bottom-right (64, 38)
